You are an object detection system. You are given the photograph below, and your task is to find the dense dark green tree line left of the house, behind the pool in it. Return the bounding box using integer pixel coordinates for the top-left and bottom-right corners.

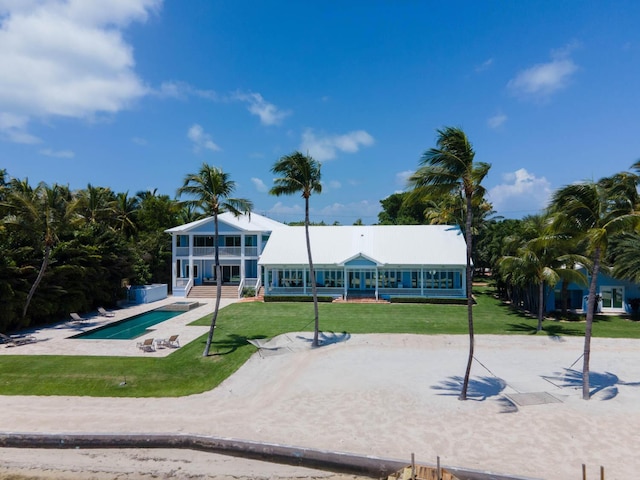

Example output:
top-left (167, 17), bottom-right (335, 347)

top-left (0, 170), bottom-right (182, 332)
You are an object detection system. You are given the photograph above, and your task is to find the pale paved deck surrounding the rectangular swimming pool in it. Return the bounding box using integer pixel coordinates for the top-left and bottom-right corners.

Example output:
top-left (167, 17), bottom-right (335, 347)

top-left (0, 296), bottom-right (237, 357)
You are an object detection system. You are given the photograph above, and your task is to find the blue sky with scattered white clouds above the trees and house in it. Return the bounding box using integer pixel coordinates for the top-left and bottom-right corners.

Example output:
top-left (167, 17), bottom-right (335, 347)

top-left (0, 0), bottom-right (640, 224)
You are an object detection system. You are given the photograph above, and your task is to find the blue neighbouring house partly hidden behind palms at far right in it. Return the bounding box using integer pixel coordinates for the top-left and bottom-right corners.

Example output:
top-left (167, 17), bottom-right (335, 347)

top-left (546, 267), bottom-right (640, 313)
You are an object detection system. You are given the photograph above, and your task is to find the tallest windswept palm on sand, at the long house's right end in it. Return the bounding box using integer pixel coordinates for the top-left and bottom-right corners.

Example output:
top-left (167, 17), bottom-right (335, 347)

top-left (409, 127), bottom-right (491, 400)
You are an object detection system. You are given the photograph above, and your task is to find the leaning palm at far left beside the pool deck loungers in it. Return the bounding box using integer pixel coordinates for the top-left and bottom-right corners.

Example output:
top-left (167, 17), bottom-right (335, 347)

top-left (4, 179), bottom-right (75, 319)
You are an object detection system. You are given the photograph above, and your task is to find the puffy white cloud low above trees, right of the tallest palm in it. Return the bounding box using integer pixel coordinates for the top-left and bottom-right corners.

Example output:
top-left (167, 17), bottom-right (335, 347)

top-left (487, 168), bottom-right (552, 218)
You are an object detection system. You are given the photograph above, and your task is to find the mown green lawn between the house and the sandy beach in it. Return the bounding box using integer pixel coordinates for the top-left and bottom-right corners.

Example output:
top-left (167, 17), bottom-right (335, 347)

top-left (0, 288), bottom-right (640, 397)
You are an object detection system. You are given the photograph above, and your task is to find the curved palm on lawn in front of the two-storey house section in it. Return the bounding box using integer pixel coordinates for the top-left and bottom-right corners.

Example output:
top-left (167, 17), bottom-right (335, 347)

top-left (178, 163), bottom-right (253, 357)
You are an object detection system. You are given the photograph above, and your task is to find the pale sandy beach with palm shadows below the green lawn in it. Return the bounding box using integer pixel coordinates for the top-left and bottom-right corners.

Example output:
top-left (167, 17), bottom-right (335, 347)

top-left (0, 333), bottom-right (640, 480)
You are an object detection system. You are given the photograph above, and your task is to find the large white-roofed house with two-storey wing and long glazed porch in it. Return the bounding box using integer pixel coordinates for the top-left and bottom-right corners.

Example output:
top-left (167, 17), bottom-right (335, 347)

top-left (167, 213), bottom-right (466, 298)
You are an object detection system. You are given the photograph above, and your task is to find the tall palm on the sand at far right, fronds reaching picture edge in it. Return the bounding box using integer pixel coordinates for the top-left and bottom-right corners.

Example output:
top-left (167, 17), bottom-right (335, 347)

top-left (551, 173), bottom-right (639, 400)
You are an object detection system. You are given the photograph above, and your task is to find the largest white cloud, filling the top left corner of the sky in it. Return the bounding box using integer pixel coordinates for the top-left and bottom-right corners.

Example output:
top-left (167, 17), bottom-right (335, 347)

top-left (0, 0), bottom-right (162, 142)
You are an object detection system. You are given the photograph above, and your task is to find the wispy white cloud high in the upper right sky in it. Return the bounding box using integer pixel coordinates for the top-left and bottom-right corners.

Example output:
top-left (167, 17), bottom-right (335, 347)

top-left (507, 43), bottom-right (578, 99)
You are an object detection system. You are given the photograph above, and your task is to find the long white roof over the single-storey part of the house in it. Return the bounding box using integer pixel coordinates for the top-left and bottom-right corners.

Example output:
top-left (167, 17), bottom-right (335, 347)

top-left (259, 225), bottom-right (467, 266)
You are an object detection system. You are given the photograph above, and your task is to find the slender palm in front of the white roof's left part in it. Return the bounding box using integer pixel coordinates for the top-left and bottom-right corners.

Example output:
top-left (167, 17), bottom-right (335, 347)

top-left (269, 152), bottom-right (322, 347)
